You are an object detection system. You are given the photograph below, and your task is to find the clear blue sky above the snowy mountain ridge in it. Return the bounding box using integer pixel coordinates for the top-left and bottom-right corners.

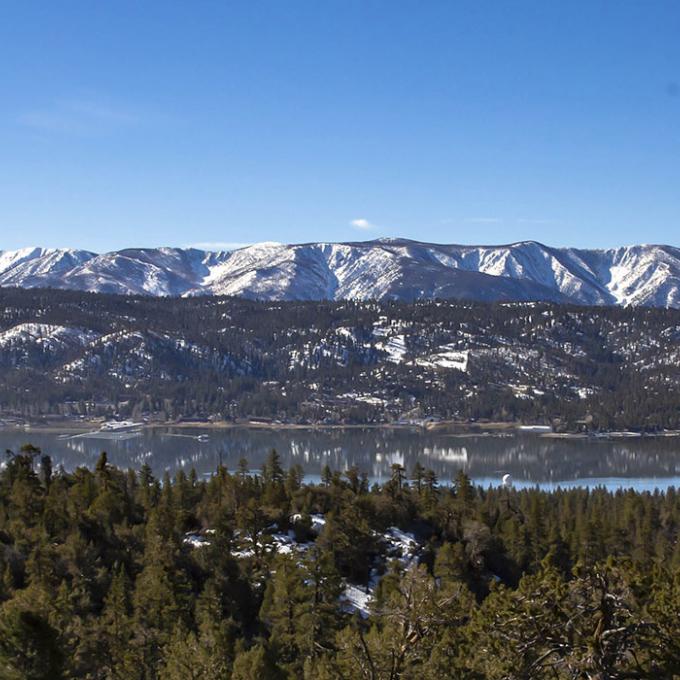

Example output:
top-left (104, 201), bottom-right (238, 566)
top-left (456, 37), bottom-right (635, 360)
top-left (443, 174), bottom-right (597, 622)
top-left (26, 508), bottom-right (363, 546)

top-left (0, 0), bottom-right (680, 251)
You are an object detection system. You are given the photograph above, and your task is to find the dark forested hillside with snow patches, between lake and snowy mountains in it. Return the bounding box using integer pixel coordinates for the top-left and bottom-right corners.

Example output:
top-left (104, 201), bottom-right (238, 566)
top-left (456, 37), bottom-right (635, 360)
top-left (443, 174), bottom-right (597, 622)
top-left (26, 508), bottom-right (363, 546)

top-left (0, 289), bottom-right (680, 430)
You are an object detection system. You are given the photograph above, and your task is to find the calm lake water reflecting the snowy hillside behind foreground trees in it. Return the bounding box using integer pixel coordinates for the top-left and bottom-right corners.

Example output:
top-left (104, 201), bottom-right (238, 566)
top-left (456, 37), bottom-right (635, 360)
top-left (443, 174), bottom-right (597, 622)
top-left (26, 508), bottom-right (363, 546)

top-left (0, 428), bottom-right (680, 490)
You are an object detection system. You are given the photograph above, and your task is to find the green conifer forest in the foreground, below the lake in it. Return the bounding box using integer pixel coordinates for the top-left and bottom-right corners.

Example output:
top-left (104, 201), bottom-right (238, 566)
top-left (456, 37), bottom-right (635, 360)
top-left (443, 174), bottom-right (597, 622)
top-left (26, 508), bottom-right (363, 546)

top-left (0, 447), bottom-right (680, 680)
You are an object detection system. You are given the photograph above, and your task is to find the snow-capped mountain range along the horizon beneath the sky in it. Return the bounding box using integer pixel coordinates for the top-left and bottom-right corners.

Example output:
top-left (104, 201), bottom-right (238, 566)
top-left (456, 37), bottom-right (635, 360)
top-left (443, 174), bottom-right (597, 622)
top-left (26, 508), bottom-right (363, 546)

top-left (0, 239), bottom-right (680, 307)
